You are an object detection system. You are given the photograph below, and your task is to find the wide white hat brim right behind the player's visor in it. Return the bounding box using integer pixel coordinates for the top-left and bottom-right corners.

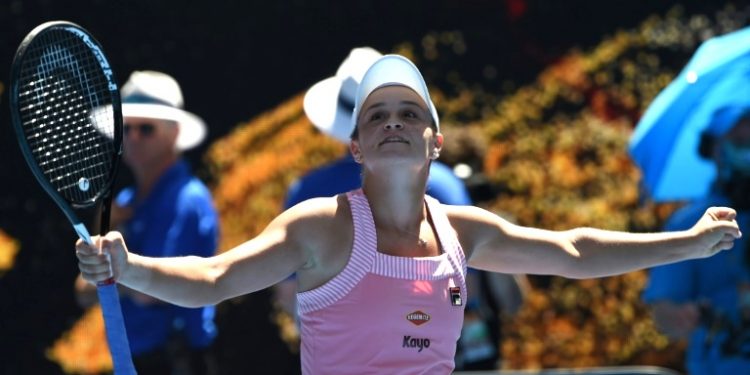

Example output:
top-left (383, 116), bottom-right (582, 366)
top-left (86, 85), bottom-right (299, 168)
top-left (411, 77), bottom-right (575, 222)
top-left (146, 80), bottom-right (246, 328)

top-left (302, 76), bottom-right (352, 143)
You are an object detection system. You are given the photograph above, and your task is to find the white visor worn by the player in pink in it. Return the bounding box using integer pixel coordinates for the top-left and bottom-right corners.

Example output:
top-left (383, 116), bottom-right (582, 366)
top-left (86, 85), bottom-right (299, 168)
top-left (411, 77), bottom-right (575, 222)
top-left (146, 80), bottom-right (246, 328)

top-left (351, 55), bottom-right (440, 132)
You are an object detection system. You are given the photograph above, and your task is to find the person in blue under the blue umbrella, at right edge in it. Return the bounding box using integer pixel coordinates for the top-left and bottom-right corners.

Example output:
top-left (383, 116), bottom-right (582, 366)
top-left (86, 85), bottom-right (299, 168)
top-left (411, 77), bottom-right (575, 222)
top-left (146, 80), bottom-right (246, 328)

top-left (643, 108), bottom-right (750, 375)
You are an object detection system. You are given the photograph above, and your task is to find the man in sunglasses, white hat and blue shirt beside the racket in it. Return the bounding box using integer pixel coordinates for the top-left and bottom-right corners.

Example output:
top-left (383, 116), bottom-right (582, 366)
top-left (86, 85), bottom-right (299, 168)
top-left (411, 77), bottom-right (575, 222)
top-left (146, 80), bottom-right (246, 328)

top-left (76, 71), bottom-right (219, 375)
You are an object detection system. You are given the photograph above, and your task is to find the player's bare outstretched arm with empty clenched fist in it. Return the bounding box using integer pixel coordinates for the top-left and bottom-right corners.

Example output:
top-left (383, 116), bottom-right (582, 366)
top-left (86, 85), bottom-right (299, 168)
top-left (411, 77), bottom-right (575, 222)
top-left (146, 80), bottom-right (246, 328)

top-left (447, 207), bottom-right (741, 278)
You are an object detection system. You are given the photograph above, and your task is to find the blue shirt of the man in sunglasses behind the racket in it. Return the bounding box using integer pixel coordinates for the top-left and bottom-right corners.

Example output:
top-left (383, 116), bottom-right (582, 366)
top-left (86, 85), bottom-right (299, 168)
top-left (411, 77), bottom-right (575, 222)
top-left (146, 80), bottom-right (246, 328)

top-left (116, 161), bottom-right (219, 355)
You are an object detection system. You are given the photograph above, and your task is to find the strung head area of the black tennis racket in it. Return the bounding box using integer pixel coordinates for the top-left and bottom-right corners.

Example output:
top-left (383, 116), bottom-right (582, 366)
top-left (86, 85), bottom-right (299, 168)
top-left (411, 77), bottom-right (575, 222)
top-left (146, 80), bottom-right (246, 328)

top-left (19, 30), bottom-right (116, 205)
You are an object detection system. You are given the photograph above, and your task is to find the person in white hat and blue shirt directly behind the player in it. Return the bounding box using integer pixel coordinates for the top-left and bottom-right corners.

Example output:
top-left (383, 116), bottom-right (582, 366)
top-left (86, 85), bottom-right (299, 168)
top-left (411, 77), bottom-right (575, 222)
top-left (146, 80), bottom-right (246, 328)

top-left (274, 47), bottom-right (528, 370)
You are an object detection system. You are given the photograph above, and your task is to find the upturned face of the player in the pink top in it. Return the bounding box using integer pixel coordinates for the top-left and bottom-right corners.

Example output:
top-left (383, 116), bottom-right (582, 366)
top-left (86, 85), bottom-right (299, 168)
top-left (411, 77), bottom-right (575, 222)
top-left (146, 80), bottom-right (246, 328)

top-left (352, 85), bottom-right (437, 168)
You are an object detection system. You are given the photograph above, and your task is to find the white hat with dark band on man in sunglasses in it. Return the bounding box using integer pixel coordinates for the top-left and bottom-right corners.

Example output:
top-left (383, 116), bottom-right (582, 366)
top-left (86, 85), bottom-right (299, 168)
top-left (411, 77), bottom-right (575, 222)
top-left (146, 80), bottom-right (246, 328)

top-left (120, 70), bottom-right (207, 150)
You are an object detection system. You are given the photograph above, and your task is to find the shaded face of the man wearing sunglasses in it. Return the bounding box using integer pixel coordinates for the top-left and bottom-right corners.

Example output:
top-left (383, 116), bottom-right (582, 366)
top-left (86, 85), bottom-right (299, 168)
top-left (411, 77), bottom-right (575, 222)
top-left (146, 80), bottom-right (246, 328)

top-left (123, 117), bottom-right (179, 168)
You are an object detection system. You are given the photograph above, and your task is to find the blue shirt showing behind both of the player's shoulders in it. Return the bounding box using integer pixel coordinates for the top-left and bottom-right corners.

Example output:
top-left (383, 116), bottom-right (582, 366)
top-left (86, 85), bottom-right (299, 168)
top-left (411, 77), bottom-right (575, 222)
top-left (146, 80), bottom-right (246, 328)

top-left (284, 153), bottom-right (471, 208)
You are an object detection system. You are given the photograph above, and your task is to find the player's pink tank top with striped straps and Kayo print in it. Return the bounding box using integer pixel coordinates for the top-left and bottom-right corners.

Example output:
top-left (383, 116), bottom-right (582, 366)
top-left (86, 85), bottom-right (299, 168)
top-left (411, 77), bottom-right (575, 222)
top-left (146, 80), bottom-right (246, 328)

top-left (297, 190), bottom-right (466, 375)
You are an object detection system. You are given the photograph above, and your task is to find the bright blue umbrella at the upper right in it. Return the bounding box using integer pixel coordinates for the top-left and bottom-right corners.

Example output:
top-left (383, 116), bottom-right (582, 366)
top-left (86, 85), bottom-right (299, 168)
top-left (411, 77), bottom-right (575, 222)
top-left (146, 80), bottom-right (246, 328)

top-left (629, 27), bottom-right (750, 202)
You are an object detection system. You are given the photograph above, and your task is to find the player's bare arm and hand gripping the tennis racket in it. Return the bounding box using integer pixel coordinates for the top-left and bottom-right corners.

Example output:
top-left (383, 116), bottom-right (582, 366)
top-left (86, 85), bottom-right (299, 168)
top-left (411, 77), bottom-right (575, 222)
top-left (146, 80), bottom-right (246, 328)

top-left (76, 201), bottom-right (325, 307)
